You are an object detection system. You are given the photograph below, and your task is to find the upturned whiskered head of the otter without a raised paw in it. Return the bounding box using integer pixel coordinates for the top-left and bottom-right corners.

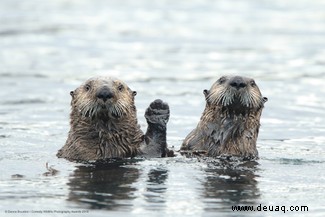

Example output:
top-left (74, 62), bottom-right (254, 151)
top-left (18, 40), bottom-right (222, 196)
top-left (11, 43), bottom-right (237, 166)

top-left (204, 76), bottom-right (267, 113)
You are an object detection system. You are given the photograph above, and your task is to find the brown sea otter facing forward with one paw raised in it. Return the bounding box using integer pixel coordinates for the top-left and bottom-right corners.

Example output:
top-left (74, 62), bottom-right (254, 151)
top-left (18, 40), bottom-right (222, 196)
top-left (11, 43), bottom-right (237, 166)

top-left (57, 77), bottom-right (171, 162)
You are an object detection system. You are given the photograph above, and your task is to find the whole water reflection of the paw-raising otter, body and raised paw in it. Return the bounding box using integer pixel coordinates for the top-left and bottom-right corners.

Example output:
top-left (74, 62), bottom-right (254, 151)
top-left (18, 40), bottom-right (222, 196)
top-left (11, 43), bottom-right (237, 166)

top-left (68, 162), bottom-right (167, 211)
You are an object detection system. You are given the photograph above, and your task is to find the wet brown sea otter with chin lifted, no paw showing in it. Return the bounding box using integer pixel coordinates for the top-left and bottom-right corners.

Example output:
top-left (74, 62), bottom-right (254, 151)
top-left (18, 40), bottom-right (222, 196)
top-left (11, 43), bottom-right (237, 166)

top-left (181, 76), bottom-right (267, 159)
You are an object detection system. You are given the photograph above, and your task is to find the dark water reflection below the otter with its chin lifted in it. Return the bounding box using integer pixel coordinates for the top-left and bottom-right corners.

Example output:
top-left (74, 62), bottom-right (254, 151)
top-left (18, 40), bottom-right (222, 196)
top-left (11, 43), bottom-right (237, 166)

top-left (203, 161), bottom-right (260, 211)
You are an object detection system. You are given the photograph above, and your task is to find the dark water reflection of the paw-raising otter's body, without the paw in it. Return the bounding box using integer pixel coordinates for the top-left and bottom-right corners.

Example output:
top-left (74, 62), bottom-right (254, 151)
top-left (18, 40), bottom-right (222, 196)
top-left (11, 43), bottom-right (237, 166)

top-left (68, 162), bottom-right (139, 210)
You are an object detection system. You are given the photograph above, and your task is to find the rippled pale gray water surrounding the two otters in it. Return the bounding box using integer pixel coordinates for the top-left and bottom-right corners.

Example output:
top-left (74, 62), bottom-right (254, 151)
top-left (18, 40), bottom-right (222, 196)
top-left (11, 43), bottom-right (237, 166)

top-left (0, 0), bottom-right (325, 216)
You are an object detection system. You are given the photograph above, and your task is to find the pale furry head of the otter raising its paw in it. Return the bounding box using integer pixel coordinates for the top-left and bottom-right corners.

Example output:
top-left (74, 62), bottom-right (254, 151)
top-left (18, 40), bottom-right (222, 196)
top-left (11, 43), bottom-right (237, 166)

top-left (70, 77), bottom-right (136, 118)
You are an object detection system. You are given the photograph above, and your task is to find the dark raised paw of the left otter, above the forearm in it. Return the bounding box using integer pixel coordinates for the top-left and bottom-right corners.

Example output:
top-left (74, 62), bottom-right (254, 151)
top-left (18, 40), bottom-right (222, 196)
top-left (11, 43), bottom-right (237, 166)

top-left (144, 99), bottom-right (169, 126)
